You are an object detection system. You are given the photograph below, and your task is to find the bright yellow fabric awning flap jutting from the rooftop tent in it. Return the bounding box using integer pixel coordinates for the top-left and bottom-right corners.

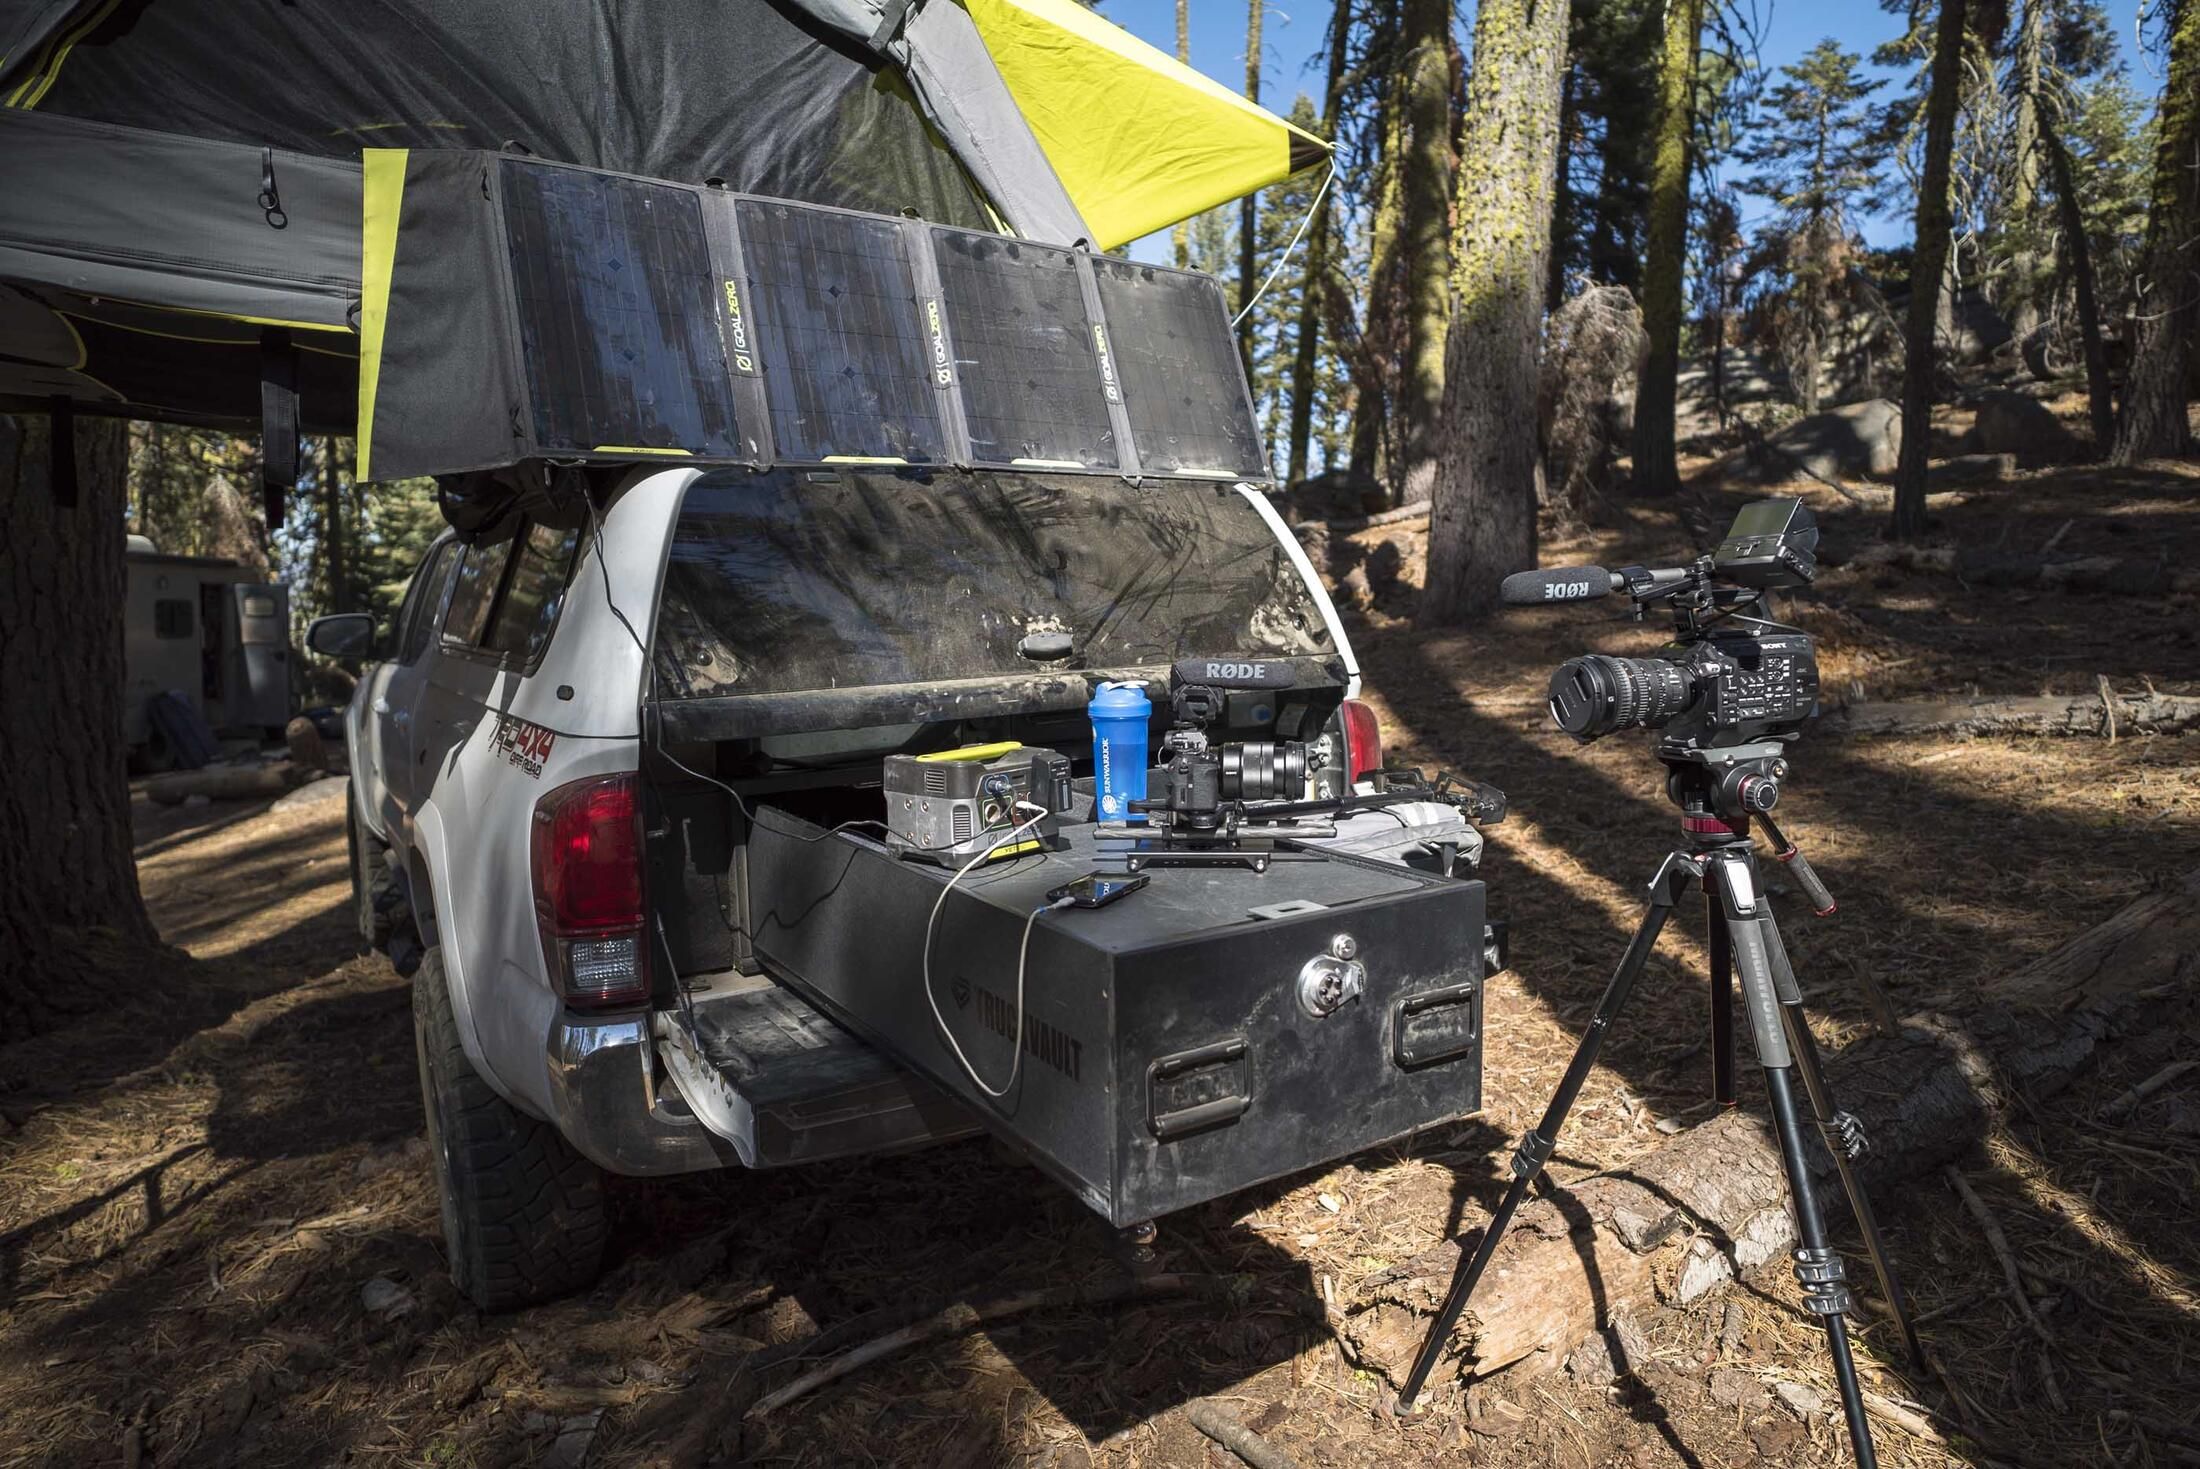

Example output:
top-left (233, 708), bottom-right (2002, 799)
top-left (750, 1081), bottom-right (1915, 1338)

top-left (961, 0), bottom-right (1329, 248)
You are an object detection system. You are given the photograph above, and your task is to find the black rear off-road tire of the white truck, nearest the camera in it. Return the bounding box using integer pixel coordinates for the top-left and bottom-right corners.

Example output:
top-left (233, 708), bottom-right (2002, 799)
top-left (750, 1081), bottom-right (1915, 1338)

top-left (414, 948), bottom-right (607, 1311)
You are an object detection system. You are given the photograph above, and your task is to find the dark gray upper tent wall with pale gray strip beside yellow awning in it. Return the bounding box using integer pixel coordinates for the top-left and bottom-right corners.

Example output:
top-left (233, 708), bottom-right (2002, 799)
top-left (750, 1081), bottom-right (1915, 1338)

top-left (0, 0), bottom-right (1085, 242)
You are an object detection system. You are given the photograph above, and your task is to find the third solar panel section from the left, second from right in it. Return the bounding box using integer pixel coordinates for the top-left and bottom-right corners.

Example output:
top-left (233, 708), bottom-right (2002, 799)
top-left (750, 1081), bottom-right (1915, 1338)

top-left (933, 229), bottom-right (1122, 468)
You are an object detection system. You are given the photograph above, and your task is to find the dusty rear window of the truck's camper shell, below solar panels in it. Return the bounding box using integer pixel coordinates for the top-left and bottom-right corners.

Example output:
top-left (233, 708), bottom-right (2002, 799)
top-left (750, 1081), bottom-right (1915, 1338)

top-left (656, 468), bottom-right (1335, 699)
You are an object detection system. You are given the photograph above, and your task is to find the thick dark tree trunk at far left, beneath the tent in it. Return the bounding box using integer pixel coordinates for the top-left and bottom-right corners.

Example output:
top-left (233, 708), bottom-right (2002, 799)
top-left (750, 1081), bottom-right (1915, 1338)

top-left (0, 406), bottom-right (158, 1042)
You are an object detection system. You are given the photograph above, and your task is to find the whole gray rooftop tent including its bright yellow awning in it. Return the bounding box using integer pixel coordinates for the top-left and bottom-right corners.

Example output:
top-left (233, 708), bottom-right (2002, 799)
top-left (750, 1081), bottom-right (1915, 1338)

top-left (0, 0), bottom-right (1318, 444)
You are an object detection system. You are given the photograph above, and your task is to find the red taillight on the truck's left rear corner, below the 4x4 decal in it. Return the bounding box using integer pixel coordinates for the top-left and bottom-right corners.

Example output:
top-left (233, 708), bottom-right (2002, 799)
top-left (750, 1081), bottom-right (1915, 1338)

top-left (528, 774), bottom-right (649, 1009)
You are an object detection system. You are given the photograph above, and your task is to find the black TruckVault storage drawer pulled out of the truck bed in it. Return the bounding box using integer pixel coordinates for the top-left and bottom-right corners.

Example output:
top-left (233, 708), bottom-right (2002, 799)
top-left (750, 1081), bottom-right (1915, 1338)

top-left (748, 809), bottom-right (1483, 1227)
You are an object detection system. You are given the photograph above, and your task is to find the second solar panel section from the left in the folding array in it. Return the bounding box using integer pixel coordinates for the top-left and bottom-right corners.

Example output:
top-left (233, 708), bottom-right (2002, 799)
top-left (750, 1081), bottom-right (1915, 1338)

top-left (735, 198), bottom-right (946, 464)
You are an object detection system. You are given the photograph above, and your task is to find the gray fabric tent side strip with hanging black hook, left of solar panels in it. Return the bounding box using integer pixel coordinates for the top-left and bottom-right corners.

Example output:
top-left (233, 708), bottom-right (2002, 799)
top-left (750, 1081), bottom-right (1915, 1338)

top-left (0, 108), bottom-right (359, 327)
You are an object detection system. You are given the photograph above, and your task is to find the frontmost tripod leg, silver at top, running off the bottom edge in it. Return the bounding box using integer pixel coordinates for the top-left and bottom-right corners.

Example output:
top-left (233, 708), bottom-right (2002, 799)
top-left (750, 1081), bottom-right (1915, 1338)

top-left (1703, 849), bottom-right (1879, 1469)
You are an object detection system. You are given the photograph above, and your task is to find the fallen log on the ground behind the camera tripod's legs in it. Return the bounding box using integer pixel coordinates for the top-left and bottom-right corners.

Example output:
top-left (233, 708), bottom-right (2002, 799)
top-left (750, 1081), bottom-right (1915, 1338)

top-left (1342, 871), bottom-right (2200, 1383)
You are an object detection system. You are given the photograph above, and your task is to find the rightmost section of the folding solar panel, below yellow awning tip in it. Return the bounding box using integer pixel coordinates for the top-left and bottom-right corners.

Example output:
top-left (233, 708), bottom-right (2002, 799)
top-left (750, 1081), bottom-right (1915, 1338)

top-left (1093, 255), bottom-right (1269, 479)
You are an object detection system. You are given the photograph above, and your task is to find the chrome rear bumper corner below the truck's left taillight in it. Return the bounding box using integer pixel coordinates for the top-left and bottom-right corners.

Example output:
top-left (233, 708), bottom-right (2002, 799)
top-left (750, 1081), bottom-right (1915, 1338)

top-left (548, 1012), bottom-right (739, 1174)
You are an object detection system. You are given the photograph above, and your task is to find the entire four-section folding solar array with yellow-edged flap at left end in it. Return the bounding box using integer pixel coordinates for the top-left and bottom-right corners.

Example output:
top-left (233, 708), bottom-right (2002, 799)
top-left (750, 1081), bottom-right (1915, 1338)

top-left (359, 150), bottom-right (1269, 479)
